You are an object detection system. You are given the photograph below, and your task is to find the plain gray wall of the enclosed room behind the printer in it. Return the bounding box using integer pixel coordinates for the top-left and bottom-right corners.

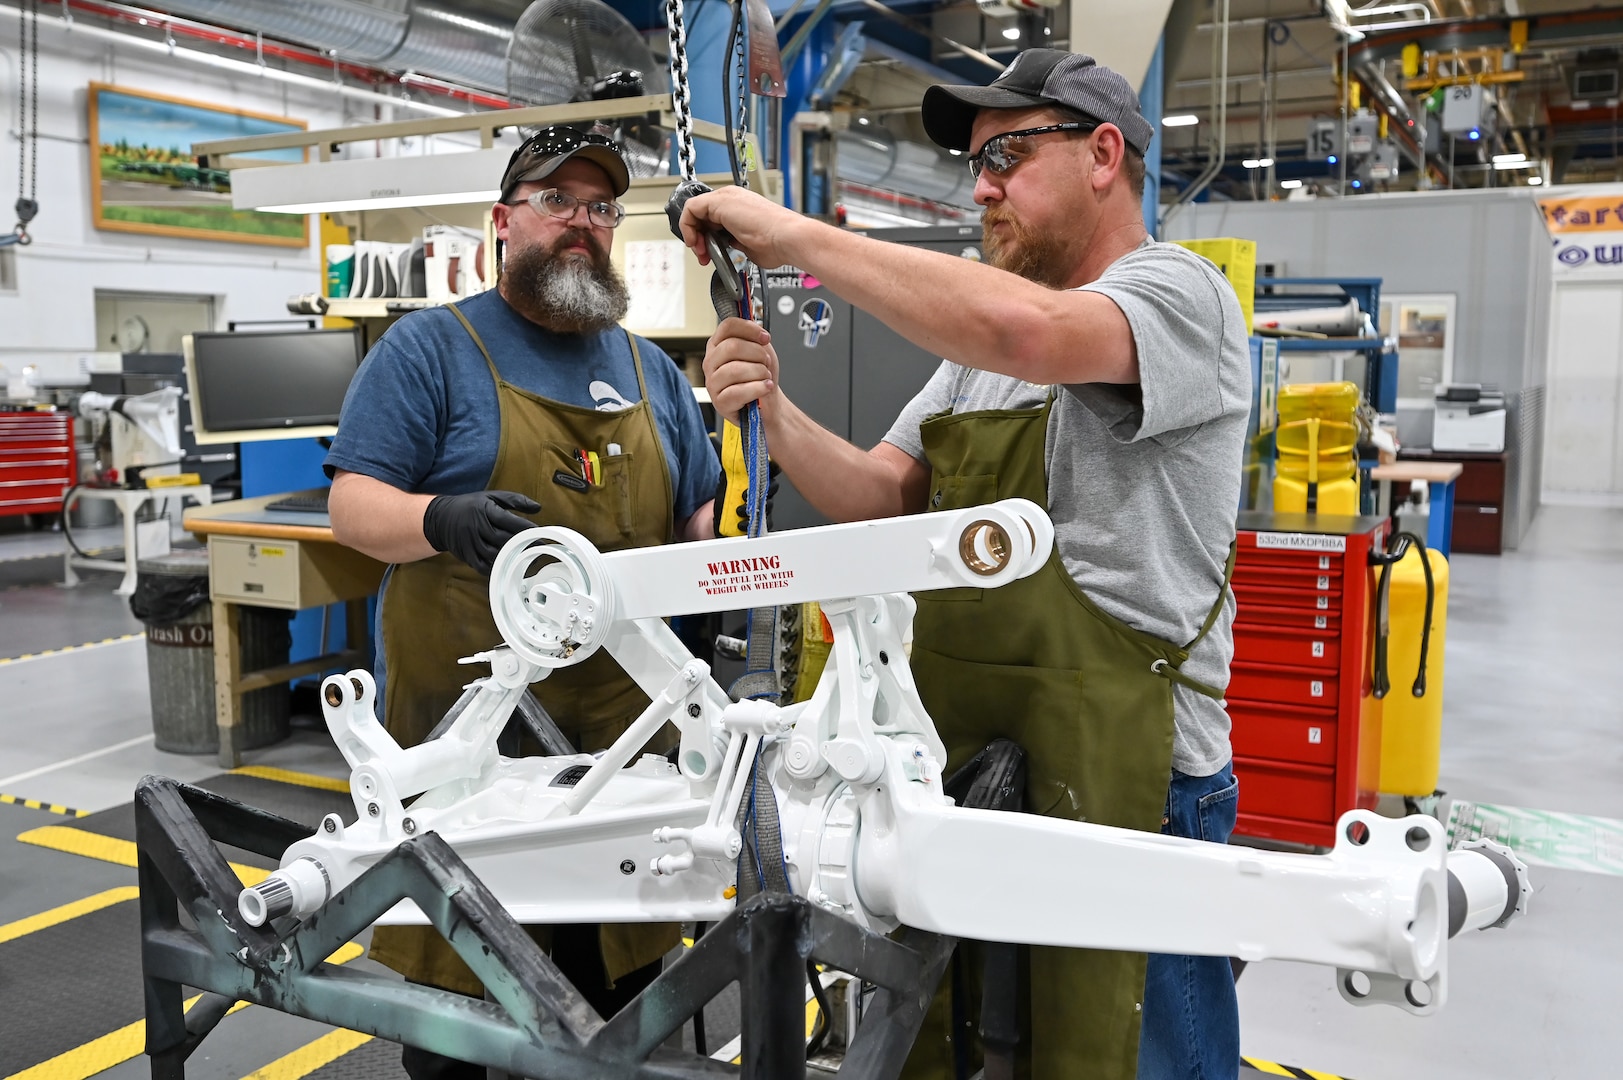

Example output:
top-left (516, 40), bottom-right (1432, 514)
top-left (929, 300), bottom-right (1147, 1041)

top-left (1165, 188), bottom-right (1552, 547)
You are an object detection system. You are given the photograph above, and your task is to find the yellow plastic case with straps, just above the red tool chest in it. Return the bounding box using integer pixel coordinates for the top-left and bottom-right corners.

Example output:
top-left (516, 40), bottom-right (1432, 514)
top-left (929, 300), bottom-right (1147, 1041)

top-left (1274, 383), bottom-right (1358, 513)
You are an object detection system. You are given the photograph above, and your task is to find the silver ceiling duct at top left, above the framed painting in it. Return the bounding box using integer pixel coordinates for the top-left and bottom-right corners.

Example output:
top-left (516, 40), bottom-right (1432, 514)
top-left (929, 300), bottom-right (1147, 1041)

top-left (151, 0), bottom-right (513, 93)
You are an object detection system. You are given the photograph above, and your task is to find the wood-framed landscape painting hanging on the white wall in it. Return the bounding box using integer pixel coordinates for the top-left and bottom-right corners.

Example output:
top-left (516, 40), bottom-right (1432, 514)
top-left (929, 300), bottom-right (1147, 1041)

top-left (89, 83), bottom-right (310, 247)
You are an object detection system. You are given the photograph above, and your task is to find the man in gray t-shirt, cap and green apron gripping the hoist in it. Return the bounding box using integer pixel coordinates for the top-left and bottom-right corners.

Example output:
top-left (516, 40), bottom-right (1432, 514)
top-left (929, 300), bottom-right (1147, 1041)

top-left (682, 49), bottom-right (1250, 1080)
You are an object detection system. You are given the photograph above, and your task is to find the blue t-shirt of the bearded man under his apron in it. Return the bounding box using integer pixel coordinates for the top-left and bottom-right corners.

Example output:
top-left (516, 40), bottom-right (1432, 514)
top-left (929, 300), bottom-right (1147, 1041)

top-left (326, 289), bottom-right (721, 526)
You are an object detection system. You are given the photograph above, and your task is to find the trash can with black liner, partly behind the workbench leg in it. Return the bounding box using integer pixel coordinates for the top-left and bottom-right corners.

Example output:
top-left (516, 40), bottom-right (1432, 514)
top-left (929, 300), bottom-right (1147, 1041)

top-left (130, 549), bottom-right (292, 754)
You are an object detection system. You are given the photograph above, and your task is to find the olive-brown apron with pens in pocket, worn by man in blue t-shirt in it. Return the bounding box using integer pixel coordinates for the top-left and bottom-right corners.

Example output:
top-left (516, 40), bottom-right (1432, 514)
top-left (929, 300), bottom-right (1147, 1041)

top-left (372, 305), bottom-right (680, 996)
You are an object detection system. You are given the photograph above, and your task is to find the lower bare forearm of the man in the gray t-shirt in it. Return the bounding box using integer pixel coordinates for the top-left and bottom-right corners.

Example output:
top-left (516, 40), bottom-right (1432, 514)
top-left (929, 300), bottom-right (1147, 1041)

top-left (766, 398), bottom-right (928, 521)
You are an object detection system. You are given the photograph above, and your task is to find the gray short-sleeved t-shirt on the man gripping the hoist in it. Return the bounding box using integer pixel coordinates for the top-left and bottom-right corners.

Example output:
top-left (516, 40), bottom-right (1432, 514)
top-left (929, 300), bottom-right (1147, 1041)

top-left (885, 240), bottom-right (1251, 776)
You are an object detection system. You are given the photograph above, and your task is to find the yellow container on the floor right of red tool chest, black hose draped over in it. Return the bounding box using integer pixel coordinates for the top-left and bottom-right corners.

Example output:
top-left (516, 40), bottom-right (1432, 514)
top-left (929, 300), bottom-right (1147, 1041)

top-left (1380, 547), bottom-right (1448, 797)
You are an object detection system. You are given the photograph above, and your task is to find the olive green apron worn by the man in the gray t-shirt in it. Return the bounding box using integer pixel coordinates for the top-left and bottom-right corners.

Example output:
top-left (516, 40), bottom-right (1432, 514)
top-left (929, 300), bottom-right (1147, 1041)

top-left (904, 393), bottom-right (1233, 1080)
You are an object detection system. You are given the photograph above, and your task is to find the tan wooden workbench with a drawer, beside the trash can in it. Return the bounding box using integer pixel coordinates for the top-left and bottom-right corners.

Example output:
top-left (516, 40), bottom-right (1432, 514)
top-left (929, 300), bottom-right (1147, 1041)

top-left (185, 492), bottom-right (386, 768)
